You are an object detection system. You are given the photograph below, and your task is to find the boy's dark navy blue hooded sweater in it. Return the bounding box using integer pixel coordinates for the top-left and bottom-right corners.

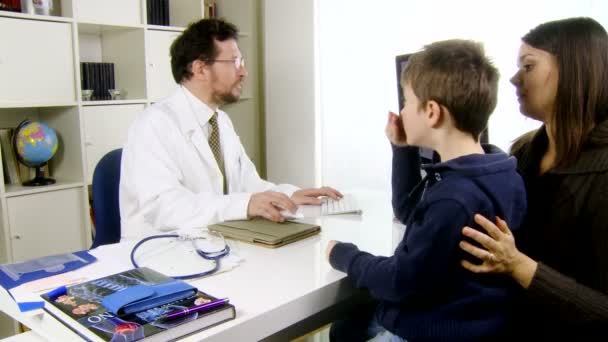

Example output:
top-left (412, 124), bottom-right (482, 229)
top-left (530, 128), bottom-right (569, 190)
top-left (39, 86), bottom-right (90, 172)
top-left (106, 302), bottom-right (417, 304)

top-left (330, 147), bottom-right (526, 342)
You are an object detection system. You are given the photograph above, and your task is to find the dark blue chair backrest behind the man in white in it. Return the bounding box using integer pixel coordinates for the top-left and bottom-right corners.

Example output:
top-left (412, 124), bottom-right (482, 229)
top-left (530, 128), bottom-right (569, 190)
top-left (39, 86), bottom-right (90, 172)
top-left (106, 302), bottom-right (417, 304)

top-left (91, 148), bottom-right (122, 248)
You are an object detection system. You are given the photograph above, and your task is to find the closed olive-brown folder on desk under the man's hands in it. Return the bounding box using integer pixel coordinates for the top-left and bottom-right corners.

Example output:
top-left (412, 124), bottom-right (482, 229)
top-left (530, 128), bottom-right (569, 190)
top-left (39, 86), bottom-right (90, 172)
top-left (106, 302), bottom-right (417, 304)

top-left (209, 219), bottom-right (321, 248)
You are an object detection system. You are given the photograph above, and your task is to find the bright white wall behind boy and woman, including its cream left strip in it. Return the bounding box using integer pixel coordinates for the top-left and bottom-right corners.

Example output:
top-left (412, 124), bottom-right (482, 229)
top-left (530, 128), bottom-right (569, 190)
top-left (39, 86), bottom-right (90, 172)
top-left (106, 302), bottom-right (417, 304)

top-left (264, 0), bottom-right (608, 189)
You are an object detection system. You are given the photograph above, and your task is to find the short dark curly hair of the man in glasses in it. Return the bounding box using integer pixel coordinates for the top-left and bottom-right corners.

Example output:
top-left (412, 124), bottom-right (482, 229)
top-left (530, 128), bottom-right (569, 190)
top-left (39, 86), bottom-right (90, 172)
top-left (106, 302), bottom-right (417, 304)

top-left (170, 18), bottom-right (239, 84)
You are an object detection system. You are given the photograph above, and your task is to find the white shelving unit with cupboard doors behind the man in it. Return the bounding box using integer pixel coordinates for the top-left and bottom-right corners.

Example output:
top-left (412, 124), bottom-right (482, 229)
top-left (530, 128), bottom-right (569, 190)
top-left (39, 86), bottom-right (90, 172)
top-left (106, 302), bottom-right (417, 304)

top-left (0, 0), bottom-right (262, 337)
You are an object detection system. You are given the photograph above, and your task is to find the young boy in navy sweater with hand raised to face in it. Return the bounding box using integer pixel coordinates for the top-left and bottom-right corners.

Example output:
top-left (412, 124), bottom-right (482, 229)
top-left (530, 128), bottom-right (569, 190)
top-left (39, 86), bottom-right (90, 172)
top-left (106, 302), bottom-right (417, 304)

top-left (327, 40), bottom-right (526, 341)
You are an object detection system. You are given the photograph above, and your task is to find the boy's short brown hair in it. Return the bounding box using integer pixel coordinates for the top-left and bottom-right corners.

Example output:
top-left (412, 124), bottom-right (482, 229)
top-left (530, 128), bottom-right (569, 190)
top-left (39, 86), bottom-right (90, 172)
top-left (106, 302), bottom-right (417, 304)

top-left (401, 39), bottom-right (499, 141)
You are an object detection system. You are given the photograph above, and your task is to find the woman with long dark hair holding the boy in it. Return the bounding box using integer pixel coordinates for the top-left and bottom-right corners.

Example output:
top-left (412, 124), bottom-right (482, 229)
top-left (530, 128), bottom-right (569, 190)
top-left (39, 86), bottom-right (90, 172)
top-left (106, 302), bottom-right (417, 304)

top-left (460, 18), bottom-right (608, 340)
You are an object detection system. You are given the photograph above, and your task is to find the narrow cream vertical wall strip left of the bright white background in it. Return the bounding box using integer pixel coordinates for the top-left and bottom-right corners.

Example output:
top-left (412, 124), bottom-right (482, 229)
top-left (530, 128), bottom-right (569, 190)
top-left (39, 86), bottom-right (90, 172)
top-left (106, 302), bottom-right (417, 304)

top-left (262, 0), bottom-right (320, 187)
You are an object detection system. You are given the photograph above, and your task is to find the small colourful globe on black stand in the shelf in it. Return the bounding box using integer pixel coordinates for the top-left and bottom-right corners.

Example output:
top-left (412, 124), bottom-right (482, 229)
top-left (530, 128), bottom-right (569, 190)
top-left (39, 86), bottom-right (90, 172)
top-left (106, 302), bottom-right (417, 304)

top-left (13, 119), bottom-right (59, 186)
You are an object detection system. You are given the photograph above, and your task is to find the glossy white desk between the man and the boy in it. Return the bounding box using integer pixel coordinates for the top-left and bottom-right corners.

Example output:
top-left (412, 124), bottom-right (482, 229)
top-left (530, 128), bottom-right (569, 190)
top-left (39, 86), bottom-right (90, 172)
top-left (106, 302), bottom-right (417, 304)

top-left (0, 191), bottom-right (404, 341)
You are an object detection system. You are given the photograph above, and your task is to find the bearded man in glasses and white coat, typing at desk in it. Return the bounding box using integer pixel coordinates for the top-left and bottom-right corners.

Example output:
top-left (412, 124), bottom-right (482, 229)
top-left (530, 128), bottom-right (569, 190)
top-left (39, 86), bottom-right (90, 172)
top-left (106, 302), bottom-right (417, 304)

top-left (120, 19), bottom-right (342, 237)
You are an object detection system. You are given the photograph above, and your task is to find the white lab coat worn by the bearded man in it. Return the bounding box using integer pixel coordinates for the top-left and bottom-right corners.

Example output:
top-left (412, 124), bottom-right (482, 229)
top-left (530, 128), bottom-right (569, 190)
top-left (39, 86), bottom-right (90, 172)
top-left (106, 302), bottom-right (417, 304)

top-left (120, 87), bottom-right (298, 237)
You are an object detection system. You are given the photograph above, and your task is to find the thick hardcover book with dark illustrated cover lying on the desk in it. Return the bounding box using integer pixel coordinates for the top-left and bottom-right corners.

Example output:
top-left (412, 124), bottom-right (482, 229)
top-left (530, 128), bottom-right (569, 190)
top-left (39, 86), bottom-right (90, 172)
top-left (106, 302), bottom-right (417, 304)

top-left (42, 267), bottom-right (236, 341)
